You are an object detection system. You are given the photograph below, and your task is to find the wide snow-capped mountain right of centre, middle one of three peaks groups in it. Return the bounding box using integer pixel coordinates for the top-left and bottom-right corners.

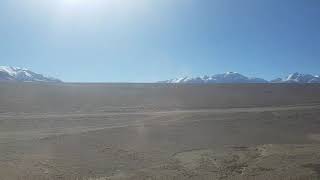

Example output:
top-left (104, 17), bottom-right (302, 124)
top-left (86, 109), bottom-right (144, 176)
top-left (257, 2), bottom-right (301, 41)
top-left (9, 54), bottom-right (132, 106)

top-left (161, 72), bottom-right (268, 84)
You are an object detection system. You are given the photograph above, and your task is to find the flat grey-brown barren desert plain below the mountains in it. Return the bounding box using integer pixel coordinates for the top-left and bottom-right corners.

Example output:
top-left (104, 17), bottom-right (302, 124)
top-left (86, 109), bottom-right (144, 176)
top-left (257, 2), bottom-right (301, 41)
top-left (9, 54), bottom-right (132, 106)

top-left (0, 83), bottom-right (320, 180)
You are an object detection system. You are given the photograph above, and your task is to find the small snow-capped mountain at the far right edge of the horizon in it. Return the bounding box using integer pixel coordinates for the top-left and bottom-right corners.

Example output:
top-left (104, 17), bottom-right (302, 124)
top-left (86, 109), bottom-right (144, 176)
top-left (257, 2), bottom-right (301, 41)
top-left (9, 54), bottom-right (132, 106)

top-left (271, 73), bottom-right (320, 83)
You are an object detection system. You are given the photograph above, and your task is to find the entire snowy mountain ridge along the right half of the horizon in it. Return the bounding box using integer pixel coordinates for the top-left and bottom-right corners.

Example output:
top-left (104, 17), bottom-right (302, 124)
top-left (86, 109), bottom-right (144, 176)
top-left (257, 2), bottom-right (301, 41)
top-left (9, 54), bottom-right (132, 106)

top-left (159, 72), bottom-right (320, 84)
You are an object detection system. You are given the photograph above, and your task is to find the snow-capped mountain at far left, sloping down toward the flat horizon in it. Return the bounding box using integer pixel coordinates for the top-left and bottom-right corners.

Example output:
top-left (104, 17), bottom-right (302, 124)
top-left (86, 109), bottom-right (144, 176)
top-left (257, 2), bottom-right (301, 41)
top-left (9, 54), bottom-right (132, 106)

top-left (0, 66), bottom-right (62, 83)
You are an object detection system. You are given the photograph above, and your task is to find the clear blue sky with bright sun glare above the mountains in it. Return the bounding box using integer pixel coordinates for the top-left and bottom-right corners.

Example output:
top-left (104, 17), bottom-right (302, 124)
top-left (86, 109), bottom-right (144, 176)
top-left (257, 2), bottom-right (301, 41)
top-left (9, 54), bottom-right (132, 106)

top-left (0, 0), bottom-right (320, 82)
